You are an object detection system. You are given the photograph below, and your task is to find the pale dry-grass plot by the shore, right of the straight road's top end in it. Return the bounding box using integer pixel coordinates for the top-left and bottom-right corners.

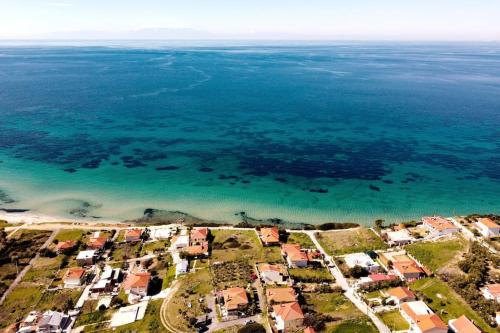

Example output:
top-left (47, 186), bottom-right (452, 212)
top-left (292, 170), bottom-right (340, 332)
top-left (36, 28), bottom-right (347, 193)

top-left (316, 227), bottom-right (387, 255)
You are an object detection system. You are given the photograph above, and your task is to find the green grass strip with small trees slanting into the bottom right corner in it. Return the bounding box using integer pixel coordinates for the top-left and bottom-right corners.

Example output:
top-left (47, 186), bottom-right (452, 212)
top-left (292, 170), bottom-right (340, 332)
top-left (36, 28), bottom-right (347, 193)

top-left (410, 278), bottom-right (496, 332)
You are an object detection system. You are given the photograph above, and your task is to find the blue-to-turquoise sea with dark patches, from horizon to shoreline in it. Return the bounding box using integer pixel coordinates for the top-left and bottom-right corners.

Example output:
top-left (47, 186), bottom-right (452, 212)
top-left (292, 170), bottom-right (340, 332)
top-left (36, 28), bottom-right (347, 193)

top-left (0, 43), bottom-right (500, 223)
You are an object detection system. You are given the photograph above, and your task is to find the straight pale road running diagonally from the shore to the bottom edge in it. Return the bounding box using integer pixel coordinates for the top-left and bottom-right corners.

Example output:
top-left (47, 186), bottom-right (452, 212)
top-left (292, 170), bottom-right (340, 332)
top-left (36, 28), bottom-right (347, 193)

top-left (305, 230), bottom-right (391, 333)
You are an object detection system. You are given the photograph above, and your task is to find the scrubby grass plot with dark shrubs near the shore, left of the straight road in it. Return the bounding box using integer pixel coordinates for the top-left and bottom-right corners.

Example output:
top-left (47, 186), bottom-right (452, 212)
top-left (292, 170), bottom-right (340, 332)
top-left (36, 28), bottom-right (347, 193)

top-left (212, 230), bottom-right (283, 263)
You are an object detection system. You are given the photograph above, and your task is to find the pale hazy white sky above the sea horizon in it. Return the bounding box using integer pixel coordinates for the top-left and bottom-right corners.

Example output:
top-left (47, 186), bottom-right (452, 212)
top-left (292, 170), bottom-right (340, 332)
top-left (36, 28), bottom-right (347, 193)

top-left (0, 0), bottom-right (500, 41)
